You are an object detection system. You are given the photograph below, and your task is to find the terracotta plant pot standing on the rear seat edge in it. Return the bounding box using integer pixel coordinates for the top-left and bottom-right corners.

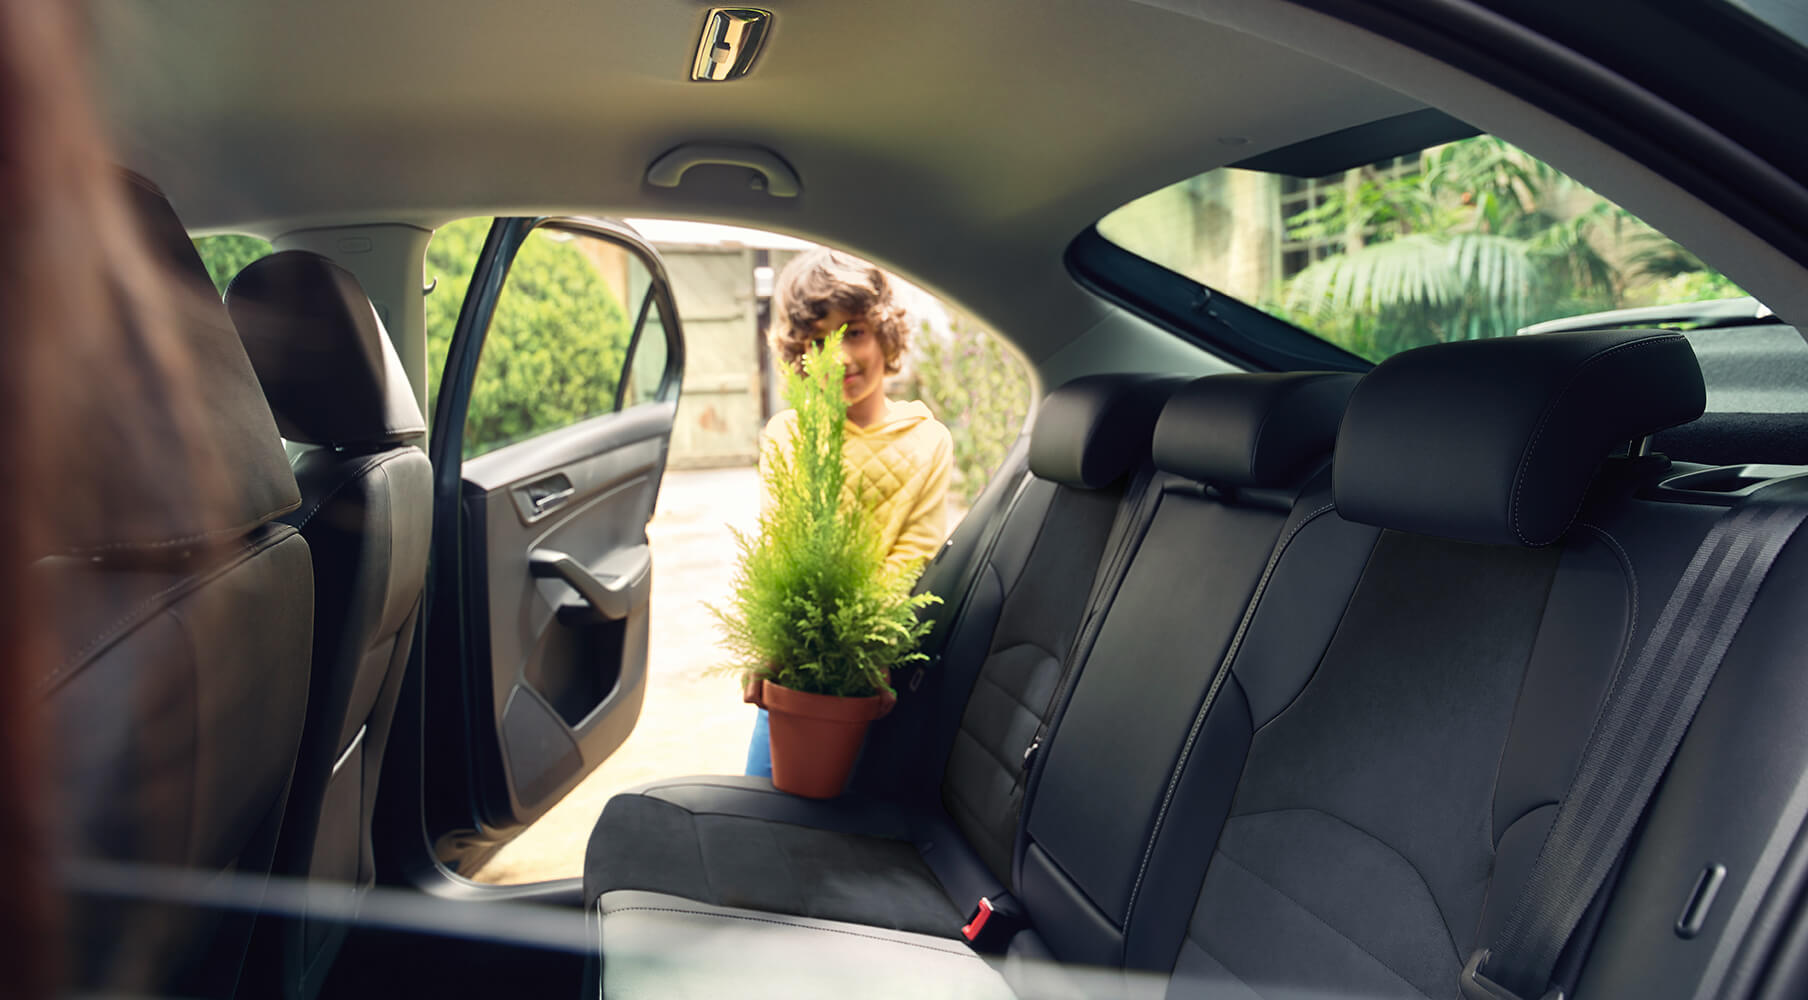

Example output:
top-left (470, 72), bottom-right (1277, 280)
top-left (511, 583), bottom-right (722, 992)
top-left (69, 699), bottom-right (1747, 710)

top-left (749, 680), bottom-right (897, 799)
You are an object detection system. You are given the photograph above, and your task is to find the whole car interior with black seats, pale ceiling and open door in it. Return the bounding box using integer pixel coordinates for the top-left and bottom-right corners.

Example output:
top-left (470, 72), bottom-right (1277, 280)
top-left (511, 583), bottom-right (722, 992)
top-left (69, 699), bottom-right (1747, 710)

top-left (34, 0), bottom-right (1808, 1000)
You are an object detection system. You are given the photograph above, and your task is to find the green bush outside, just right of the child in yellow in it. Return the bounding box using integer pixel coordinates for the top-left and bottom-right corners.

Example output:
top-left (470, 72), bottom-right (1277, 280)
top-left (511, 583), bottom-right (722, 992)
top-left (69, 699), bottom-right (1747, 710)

top-left (904, 316), bottom-right (1031, 508)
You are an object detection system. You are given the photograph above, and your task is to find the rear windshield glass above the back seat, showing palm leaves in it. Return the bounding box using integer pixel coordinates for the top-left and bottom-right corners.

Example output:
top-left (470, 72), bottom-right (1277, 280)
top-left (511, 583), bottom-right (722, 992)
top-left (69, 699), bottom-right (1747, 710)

top-left (1099, 136), bottom-right (1743, 360)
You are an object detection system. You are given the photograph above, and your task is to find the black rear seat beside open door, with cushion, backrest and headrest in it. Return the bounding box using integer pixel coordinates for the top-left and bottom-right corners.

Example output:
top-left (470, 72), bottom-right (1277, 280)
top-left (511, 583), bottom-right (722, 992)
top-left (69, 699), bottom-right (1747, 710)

top-left (584, 376), bottom-right (1177, 937)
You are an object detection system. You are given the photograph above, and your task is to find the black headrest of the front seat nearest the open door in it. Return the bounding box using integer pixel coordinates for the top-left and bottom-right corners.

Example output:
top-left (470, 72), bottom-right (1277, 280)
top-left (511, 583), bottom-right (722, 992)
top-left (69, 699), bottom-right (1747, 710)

top-left (226, 250), bottom-right (427, 445)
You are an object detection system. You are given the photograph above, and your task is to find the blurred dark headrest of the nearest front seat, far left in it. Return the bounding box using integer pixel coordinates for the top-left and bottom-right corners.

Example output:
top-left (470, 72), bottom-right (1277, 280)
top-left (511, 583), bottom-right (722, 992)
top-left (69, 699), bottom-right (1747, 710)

top-left (45, 174), bottom-right (302, 557)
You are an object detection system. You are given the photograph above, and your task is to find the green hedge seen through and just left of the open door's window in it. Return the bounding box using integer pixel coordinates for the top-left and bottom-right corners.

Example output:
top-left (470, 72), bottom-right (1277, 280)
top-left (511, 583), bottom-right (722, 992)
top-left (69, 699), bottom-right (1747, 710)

top-left (427, 219), bottom-right (633, 458)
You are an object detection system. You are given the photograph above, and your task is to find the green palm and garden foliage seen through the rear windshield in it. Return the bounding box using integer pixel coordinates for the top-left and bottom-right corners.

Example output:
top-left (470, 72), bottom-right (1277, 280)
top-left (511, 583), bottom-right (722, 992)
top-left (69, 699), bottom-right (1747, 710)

top-left (1266, 136), bottom-right (1739, 360)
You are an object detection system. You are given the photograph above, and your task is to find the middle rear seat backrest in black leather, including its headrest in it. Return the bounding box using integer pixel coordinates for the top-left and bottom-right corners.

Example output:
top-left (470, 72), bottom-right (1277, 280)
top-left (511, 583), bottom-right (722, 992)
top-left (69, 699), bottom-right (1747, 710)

top-left (1016, 373), bottom-right (1356, 966)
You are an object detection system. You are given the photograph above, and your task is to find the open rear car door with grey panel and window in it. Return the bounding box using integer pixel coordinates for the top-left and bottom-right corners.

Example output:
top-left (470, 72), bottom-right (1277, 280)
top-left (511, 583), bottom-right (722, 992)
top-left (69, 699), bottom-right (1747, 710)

top-left (423, 219), bottom-right (683, 873)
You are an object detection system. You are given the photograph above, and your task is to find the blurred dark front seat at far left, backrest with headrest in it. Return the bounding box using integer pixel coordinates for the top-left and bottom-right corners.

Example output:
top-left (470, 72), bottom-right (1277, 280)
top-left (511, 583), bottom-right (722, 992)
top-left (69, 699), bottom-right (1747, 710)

top-left (34, 177), bottom-right (313, 996)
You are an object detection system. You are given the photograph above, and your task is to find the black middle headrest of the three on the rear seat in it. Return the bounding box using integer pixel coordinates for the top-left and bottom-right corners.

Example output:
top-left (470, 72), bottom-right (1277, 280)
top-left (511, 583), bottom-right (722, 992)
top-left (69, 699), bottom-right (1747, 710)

top-left (1154, 371), bottom-right (1361, 486)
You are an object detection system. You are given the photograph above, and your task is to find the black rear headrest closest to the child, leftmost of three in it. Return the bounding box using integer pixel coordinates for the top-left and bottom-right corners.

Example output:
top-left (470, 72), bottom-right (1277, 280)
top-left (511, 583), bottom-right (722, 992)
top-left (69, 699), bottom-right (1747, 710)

top-left (1029, 374), bottom-right (1182, 490)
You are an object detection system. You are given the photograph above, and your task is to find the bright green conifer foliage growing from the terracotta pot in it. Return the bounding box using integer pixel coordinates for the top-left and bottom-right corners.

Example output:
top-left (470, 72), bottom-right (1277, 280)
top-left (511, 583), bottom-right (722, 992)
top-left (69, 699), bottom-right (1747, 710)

top-left (711, 331), bottom-right (938, 698)
